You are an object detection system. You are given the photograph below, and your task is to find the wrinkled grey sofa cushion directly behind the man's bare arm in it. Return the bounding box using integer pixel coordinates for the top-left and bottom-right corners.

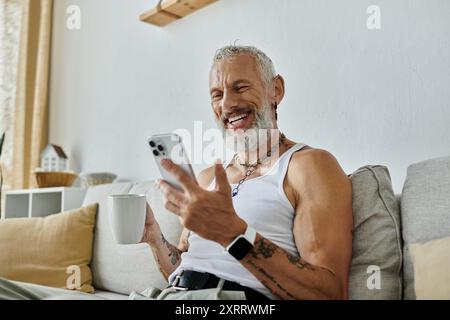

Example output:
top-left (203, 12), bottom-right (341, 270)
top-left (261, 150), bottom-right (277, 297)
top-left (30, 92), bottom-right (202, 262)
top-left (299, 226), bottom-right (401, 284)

top-left (349, 166), bottom-right (402, 300)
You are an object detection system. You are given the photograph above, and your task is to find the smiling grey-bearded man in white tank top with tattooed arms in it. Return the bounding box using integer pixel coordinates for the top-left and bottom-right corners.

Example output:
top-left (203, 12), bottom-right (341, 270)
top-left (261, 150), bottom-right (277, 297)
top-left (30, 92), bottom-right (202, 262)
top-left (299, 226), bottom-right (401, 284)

top-left (143, 46), bottom-right (353, 300)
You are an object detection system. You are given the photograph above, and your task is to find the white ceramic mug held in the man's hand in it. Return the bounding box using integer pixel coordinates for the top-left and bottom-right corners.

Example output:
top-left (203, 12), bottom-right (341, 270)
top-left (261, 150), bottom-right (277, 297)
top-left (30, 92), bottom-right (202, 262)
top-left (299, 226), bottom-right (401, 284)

top-left (108, 194), bottom-right (146, 244)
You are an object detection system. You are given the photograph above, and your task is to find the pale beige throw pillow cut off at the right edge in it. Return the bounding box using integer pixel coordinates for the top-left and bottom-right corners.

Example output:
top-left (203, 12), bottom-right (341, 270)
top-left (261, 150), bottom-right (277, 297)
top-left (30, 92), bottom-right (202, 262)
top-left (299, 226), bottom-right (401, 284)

top-left (409, 237), bottom-right (450, 300)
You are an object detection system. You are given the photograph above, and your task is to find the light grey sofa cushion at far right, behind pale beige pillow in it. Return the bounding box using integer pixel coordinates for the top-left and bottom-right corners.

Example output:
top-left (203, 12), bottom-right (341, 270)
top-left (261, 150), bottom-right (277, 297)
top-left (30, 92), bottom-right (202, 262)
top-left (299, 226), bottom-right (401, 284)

top-left (401, 157), bottom-right (450, 299)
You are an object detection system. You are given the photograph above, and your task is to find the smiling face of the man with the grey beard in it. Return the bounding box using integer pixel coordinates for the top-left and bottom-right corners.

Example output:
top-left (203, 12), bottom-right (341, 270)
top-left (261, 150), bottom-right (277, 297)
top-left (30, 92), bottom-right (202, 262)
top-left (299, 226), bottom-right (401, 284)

top-left (210, 54), bottom-right (273, 132)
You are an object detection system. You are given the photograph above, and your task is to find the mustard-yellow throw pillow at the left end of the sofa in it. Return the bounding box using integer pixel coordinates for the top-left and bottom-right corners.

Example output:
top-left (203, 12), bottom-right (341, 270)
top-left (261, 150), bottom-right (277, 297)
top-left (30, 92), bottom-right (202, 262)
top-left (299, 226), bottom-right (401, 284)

top-left (0, 204), bottom-right (98, 293)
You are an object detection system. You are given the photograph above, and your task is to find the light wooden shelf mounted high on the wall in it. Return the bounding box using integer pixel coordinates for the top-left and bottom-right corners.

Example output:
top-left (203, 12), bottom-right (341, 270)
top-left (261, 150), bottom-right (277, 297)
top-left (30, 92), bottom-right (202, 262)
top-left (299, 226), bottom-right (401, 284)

top-left (140, 0), bottom-right (219, 27)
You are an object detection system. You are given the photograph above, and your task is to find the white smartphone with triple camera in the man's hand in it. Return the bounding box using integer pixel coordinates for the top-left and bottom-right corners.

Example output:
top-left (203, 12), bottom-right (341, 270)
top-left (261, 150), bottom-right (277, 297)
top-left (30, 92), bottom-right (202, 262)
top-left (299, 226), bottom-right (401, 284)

top-left (148, 133), bottom-right (197, 189)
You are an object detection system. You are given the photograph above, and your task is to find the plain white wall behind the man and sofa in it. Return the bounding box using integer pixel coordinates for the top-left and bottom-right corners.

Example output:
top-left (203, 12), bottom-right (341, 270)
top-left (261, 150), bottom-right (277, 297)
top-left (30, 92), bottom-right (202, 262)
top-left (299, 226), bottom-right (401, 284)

top-left (50, 0), bottom-right (450, 192)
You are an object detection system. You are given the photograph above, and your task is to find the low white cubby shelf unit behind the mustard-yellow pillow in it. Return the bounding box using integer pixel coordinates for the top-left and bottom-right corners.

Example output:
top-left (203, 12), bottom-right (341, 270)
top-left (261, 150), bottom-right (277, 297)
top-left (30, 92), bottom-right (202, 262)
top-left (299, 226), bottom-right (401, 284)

top-left (4, 188), bottom-right (86, 219)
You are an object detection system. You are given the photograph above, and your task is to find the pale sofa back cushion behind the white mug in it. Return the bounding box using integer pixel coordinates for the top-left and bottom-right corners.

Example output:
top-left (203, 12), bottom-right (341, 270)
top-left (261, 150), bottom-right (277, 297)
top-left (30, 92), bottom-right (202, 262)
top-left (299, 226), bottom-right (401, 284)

top-left (85, 182), bottom-right (181, 295)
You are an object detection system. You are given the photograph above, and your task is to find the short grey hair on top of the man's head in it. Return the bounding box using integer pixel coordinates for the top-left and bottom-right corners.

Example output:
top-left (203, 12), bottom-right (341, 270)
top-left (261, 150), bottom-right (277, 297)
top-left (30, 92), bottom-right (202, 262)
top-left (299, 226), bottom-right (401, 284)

top-left (213, 45), bottom-right (277, 84)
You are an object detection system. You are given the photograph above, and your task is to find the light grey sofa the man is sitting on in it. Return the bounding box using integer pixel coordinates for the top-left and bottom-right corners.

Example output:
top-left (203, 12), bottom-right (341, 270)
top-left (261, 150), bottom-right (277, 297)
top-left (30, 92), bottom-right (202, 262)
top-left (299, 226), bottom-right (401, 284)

top-left (83, 157), bottom-right (450, 299)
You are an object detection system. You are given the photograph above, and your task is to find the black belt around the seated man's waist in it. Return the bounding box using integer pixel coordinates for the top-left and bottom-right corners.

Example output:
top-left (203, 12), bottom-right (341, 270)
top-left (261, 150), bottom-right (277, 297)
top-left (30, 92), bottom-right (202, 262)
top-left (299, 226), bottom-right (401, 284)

top-left (169, 270), bottom-right (270, 300)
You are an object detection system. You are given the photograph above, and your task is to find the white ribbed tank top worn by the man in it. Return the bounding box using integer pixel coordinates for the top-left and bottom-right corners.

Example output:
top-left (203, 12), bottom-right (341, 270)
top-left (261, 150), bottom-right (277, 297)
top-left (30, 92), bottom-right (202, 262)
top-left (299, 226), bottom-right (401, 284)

top-left (169, 143), bottom-right (306, 299)
